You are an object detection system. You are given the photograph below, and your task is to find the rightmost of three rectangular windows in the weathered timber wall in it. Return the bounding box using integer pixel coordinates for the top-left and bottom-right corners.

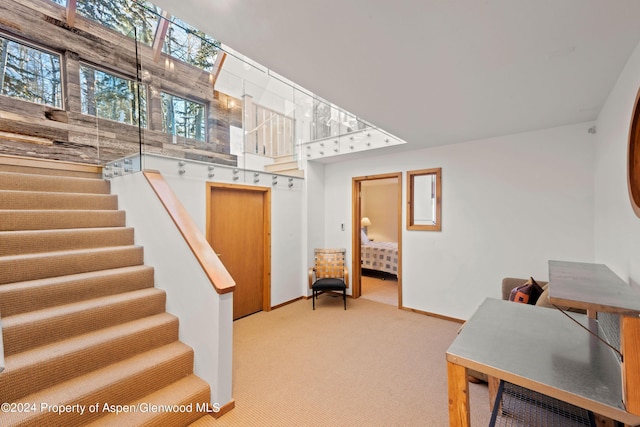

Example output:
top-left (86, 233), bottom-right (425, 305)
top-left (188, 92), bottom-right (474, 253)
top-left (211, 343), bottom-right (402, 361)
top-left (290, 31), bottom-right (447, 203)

top-left (161, 92), bottom-right (206, 141)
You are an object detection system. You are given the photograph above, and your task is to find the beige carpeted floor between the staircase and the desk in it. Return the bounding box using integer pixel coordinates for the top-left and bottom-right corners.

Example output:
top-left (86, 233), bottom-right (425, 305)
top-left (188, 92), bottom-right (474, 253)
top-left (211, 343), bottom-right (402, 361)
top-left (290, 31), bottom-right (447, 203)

top-left (216, 295), bottom-right (490, 426)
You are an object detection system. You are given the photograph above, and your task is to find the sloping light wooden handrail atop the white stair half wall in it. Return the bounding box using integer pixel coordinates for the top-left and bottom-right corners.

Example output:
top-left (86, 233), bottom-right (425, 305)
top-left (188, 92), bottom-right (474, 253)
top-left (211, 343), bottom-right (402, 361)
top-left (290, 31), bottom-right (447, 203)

top-left (143, 170), bottom-right (236, 294)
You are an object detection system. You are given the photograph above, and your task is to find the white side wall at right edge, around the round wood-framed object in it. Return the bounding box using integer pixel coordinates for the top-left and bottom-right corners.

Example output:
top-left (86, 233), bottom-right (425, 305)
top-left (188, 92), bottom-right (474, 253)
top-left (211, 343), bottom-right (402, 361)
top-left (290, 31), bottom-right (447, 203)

top-left (595, 40), bottom-right (640, 284)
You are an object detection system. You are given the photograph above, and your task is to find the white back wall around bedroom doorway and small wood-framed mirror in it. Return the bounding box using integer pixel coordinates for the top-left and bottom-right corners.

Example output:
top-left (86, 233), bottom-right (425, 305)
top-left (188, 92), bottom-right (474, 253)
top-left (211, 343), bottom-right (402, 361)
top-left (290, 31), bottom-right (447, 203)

top-left (324, 123), bottom-right (595, 319)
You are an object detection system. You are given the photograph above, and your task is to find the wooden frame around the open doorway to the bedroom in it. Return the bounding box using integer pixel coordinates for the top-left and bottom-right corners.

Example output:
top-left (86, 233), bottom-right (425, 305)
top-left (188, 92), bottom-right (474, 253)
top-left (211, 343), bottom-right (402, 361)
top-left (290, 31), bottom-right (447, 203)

top-left (351, 172), bottom-right (403, 308)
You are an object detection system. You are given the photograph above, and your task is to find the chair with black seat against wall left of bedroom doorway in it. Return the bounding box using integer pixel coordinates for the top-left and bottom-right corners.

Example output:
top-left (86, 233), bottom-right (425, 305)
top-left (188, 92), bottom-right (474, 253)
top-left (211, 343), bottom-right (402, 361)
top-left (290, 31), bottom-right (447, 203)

top-left (309, 249), bottom-right (349, 310)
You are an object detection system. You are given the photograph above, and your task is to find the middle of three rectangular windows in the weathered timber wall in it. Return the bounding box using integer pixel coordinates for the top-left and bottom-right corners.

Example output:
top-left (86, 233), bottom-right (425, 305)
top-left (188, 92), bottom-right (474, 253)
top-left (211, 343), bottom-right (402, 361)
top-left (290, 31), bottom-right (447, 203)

top-left (80, 64), bottom-right (147, 127)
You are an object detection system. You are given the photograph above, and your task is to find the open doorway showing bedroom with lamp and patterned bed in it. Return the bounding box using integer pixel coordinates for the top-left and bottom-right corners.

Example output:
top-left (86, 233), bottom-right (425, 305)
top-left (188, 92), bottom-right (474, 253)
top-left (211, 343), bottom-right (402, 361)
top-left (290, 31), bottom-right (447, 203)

top-left (351, 172), bottom-right (402, 308)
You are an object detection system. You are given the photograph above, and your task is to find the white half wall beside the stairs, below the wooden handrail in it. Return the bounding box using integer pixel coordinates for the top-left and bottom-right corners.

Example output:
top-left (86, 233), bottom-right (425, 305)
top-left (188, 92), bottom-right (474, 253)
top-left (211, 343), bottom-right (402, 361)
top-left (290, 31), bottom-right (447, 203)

top-left (111, 173), bottom-right (233, 406)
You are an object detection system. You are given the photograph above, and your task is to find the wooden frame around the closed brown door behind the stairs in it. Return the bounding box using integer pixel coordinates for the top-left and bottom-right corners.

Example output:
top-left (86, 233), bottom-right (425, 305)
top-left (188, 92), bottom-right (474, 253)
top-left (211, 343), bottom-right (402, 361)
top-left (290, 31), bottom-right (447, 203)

top-left (206, 182), bottom-right (271, 311)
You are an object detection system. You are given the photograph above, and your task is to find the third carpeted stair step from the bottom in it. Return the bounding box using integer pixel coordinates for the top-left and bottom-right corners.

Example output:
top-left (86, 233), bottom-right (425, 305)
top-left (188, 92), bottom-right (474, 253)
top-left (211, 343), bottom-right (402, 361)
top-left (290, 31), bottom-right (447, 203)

top-left (0, 313), bottom-right (178, 402)
